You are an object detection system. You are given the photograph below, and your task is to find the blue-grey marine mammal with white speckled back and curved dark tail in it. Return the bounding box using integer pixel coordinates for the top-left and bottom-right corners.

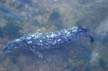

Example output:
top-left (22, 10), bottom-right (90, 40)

top-left (3, 27), bottom-right (94, 52)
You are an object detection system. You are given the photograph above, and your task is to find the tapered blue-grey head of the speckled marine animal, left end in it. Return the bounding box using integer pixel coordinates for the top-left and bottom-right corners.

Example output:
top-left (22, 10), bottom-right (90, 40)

top-left (3, 38), bottom-right (31, 54)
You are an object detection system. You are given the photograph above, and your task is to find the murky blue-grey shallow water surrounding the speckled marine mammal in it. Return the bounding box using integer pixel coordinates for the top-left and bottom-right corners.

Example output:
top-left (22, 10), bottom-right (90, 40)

top-left (0, 0), bottom-right (108, 71)
